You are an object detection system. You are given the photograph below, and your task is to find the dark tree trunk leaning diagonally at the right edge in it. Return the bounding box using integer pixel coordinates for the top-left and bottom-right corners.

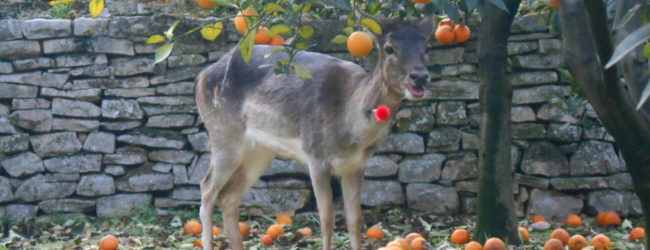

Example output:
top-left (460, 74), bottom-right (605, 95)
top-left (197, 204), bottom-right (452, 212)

top-left (560, 0), bottom-right (650, 249)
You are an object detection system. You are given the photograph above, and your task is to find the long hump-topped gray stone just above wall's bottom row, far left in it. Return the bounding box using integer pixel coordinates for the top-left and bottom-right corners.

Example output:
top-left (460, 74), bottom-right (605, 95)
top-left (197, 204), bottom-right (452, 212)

top-left (16, 174), bottom-right (77, 202)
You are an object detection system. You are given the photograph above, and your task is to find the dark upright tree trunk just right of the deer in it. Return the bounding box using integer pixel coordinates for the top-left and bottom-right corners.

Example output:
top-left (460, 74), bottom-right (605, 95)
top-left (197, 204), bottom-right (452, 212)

top-left (476, 0), bottom-right (520, 244)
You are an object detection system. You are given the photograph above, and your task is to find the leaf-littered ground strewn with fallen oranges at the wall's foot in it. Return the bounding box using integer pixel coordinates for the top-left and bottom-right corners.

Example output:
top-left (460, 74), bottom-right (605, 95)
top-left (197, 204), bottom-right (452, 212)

top-left (0, 208), bottom-right (643, 249)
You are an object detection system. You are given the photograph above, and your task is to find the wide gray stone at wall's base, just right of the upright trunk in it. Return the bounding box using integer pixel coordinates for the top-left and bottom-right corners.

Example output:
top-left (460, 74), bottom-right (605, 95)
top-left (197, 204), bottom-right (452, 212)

top-left (528, 189), bottom-right (584, 221)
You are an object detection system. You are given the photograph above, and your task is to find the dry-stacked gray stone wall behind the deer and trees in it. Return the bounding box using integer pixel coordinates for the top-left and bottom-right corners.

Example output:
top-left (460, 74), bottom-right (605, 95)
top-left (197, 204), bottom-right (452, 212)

top-left (0, 13), bottom-right (641, 220)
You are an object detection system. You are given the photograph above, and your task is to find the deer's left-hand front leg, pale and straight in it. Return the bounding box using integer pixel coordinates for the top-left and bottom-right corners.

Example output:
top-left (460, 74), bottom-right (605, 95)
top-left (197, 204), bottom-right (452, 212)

top-left (309, 163), bottom-right (334, 250)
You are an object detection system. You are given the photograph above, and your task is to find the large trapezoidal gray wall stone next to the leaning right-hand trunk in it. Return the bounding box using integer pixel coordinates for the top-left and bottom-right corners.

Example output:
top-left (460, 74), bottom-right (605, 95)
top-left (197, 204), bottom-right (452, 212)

top-left (569, 141), bottom-right (625, 176)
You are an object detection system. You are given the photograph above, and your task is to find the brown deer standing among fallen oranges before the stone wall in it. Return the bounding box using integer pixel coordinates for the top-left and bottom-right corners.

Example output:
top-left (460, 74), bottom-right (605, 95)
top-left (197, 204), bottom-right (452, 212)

top-left (195, 17), bottom-right (434, 250)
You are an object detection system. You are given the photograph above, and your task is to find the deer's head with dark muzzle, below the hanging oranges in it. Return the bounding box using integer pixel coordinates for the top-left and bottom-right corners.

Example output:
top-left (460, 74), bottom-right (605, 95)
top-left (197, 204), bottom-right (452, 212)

top-left (377, 17), bottom-right (434, 100)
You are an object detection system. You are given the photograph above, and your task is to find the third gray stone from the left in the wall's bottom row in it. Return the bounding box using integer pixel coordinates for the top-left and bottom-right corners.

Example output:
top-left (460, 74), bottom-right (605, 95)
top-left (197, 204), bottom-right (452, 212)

top-left (97, 194), bottom-right (152, 217)
